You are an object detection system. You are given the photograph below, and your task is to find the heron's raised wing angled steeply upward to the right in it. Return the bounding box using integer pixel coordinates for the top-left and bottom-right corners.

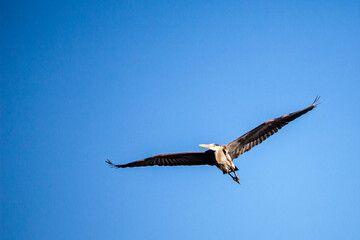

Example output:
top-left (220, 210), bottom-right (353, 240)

top-left (226, 97), bottom-right (320, 159)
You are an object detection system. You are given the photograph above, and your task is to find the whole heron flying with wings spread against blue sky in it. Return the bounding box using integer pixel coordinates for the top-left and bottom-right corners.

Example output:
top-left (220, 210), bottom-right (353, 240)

top-left (106, 97), bottom-right (320, 184)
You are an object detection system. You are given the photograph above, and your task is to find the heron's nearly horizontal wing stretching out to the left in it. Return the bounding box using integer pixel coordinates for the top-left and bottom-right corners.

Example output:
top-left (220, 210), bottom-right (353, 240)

top-left (106, 150), bottom-right (215, 168)
